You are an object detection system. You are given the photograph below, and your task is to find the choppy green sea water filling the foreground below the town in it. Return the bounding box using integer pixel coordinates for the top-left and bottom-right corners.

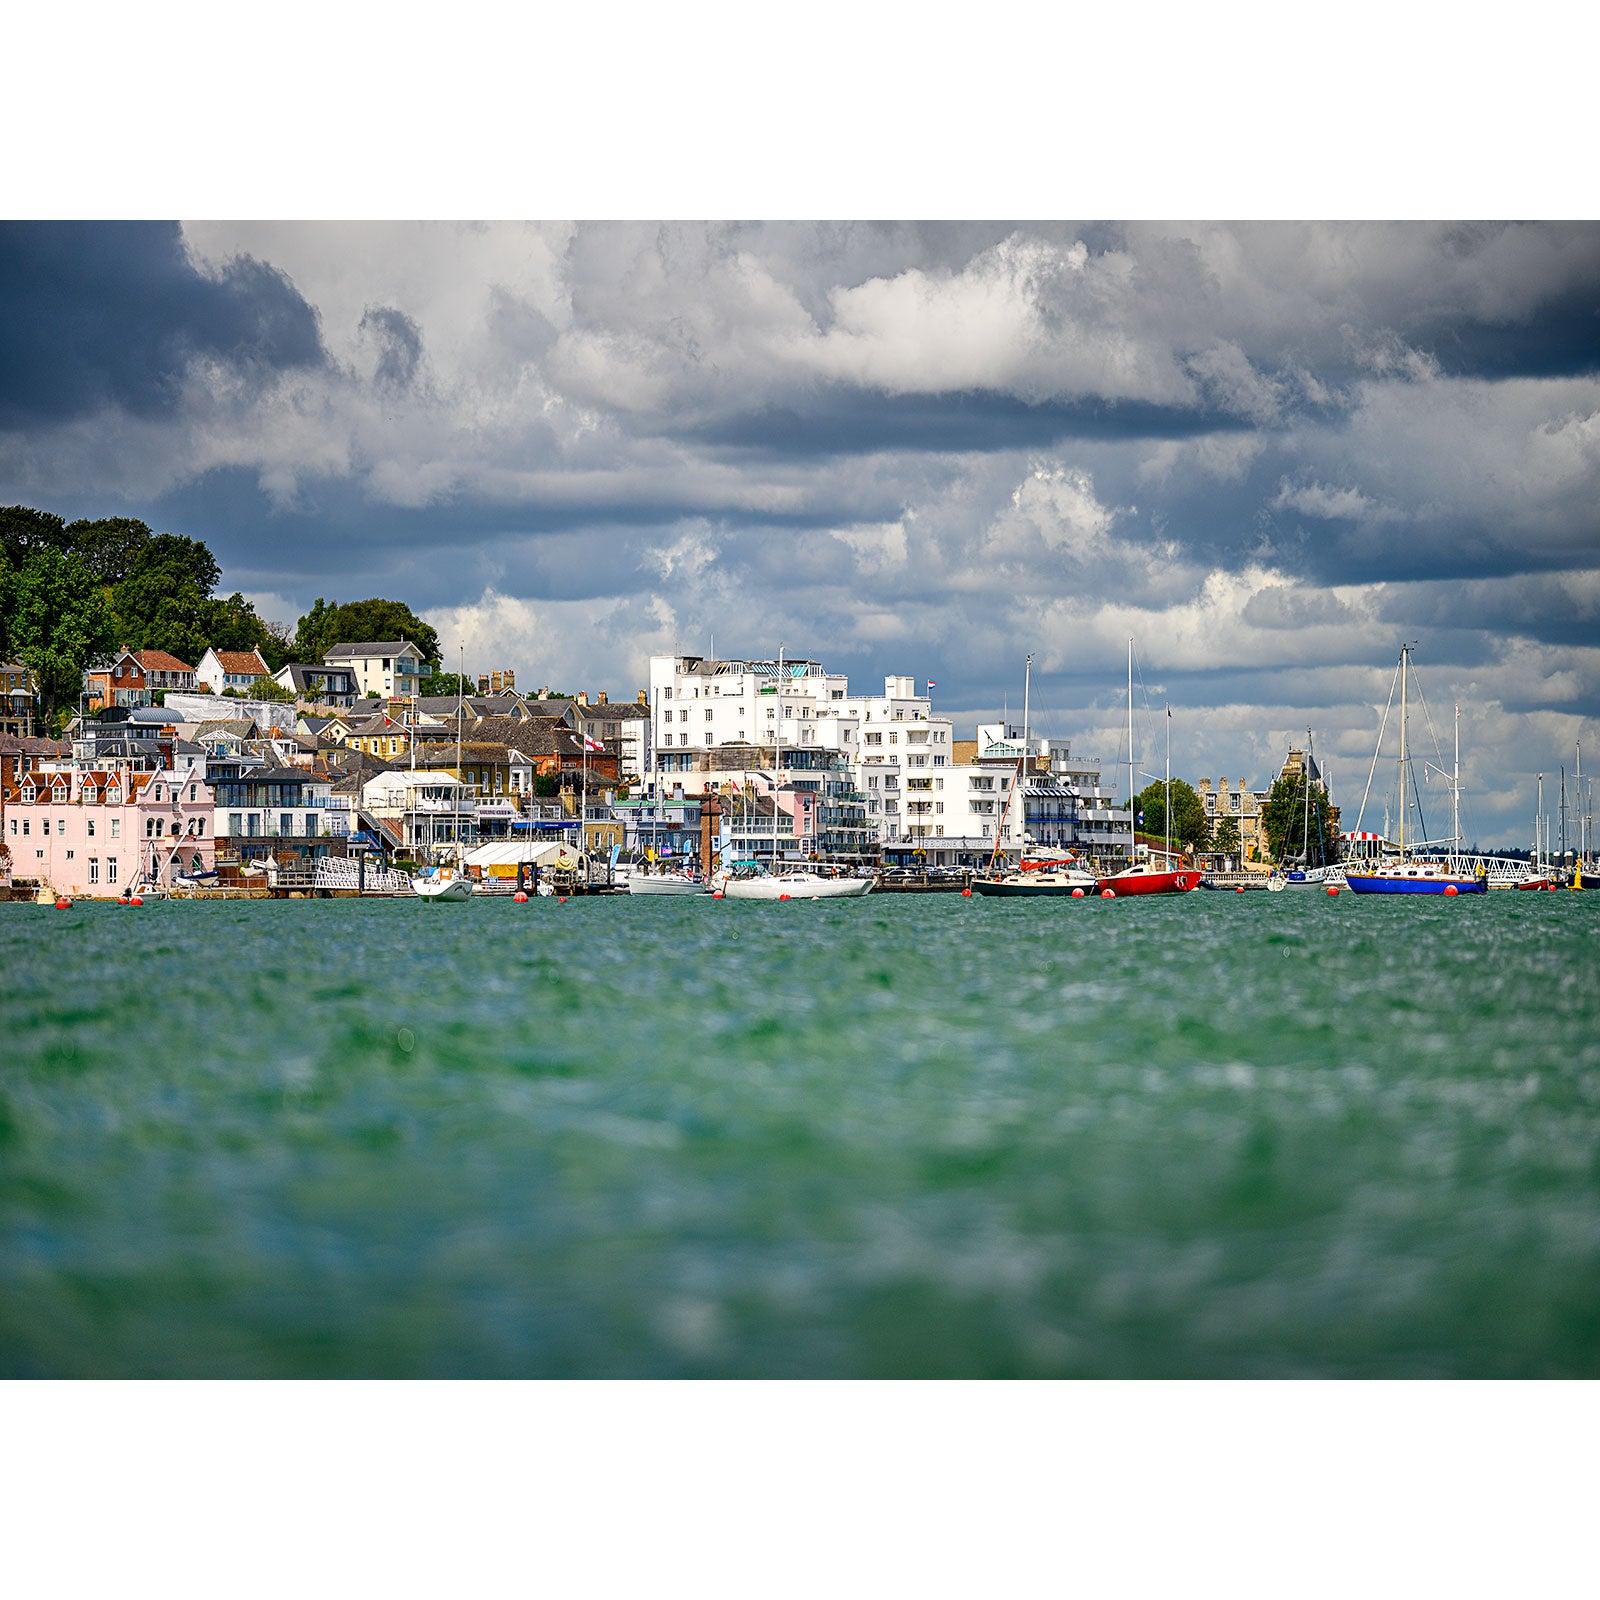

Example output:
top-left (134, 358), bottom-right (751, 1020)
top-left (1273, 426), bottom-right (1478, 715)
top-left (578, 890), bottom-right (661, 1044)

top-left (0, 891), bottom-right (1600, 1376)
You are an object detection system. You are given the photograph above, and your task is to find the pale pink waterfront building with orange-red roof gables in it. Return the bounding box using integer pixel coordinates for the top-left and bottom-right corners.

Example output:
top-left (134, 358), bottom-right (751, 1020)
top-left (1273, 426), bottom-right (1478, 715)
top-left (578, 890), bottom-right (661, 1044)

top-left (5, 770), bottom-right (216, 899)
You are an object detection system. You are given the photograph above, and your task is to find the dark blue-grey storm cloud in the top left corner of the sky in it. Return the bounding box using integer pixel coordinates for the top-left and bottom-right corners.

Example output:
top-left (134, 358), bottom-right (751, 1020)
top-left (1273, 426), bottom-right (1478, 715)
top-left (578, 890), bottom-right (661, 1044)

top-left (0, 222), bottom-right (323, 427)
